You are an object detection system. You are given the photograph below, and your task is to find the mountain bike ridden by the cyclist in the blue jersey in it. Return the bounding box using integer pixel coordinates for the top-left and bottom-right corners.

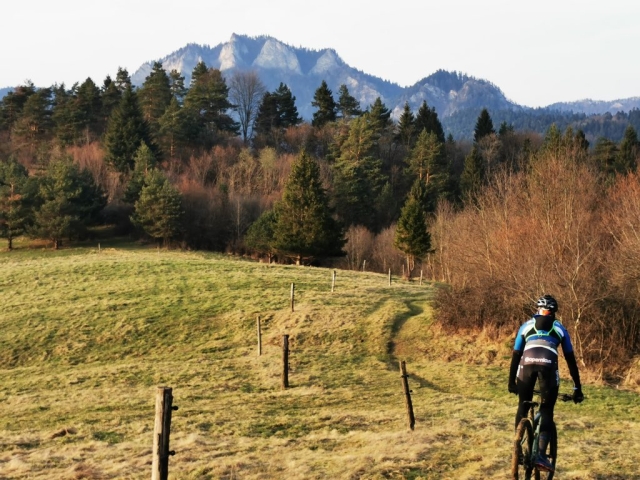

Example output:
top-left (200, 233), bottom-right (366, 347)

top-left (511, 390), bottom-right (573, 480)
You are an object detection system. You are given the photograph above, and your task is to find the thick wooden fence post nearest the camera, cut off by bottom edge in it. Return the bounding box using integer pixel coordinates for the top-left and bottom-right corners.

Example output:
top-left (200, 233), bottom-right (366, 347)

top-left (151, 387), bottom-right (178, 480)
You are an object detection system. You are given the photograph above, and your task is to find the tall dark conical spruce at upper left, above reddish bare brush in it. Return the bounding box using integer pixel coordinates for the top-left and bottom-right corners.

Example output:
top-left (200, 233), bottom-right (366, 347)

top-left (104, 85), bottom-right (155, 174)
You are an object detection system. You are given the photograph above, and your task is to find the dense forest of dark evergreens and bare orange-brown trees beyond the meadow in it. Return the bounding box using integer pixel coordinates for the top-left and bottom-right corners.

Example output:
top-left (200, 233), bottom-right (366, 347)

top-left (0, 62), bottom-right (640, 378)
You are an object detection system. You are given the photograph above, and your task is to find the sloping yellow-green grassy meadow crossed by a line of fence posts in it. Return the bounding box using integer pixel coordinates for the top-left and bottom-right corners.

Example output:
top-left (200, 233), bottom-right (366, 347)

top-left (0, 243), bottom-right (640, 480)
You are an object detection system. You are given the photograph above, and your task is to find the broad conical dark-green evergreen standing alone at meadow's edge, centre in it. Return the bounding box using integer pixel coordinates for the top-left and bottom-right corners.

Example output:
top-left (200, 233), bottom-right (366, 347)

top-left (274, 151), bottom-right (345, 263)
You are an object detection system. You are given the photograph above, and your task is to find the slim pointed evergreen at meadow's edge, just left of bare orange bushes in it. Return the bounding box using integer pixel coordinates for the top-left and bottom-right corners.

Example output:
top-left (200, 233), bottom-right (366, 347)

top-left (393, 180), bottom-right (431, 279)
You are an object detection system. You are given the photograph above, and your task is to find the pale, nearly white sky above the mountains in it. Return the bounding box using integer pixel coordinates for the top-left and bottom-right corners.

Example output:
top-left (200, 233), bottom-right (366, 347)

top-left (0, 0), bottom-right (640, 107)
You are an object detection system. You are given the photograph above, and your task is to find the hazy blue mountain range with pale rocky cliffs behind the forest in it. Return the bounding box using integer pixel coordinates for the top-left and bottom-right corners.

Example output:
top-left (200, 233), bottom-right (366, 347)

top-left (0, 34), bottom-right (640, 138)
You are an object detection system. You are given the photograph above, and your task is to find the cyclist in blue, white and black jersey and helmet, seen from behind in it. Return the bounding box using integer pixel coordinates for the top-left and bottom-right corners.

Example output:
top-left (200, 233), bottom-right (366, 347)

top-left (509, 295), bottom-right (584, 472)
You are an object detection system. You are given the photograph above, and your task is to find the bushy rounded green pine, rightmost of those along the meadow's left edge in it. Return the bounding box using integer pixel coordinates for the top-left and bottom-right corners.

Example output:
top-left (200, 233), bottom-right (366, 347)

top-left (131, 169), bottom-right (184, 246)
